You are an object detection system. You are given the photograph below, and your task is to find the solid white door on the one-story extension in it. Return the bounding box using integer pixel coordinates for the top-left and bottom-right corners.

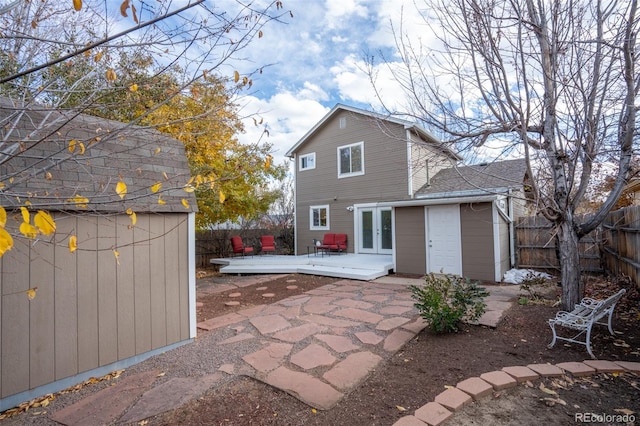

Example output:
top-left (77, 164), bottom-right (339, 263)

top-left (425, 204), bottom-right (462, 275)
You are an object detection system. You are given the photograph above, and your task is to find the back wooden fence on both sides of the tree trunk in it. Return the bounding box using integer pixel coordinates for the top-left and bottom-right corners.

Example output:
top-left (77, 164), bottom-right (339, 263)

top-left (515, 216), bottom-right (602, 272)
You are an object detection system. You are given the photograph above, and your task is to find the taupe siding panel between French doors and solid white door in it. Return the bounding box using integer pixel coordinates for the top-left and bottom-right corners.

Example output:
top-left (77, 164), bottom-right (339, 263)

top-left (394, 207), bottom-right (427, 275)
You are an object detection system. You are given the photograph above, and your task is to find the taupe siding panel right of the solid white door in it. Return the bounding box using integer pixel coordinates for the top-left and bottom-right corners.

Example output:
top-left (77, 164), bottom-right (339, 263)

top-left (460, 203), bottom-right (495, 281)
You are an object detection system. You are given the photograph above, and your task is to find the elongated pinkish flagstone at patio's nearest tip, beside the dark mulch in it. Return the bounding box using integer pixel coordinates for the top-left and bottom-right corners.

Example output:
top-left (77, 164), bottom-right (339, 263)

top-left (265, 367), bottom-right (344, 410)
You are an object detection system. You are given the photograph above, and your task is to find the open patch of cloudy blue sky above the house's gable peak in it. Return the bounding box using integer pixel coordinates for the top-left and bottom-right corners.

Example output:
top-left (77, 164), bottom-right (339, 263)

top-left (222, 0), bottom-right (428, 166)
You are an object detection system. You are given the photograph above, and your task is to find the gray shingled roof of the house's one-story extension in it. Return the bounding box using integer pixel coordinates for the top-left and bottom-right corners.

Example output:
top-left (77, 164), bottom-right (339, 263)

top-left (416, 159), bottom-right (527, 197)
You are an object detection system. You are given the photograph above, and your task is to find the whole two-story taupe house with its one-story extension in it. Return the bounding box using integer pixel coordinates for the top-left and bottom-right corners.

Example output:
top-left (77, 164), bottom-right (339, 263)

top-left (287, 104), bottom-right (526, 281)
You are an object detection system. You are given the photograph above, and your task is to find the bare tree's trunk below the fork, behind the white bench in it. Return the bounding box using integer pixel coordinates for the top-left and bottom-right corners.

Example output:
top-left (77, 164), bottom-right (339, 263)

top-left (557, 220), bottom-right (583, 311)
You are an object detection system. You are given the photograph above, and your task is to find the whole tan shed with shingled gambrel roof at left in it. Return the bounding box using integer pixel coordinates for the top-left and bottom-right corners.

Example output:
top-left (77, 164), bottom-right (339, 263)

top-left (0, 99), bottom-right (196, 411)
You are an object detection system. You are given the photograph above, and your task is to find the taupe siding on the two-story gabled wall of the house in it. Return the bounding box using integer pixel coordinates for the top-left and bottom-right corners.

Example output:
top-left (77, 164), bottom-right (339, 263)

top-left (295, 110), bottom-right (410, 254)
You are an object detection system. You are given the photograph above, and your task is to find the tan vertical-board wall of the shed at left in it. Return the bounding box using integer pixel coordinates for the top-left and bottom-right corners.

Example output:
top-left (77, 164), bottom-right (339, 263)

top-left (0, 214), bottom-right (189, 398)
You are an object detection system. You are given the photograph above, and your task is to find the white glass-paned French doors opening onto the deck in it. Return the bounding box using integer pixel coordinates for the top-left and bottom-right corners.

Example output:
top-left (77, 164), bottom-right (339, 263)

top-left (358, 207), bottom-right (393, 254)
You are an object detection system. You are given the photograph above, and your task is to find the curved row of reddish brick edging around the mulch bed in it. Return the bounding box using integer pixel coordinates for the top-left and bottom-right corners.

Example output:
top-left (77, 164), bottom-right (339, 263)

top-left (394, 360), bottom-right (640, 426)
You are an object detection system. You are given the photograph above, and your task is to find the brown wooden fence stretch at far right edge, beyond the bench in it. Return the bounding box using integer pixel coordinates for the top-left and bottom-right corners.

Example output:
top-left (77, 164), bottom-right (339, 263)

top-left (602, 206), bottom-right (640, 283)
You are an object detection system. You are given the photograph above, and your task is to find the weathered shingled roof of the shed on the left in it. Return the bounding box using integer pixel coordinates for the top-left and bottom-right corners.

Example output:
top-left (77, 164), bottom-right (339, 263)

top-left (0, 98), bottom-right (197, 213)
